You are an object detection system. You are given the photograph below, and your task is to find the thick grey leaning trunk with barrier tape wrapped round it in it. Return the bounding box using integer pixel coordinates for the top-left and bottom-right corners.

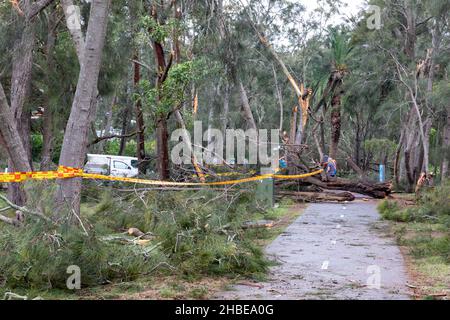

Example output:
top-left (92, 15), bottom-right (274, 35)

top-left (57, 0), bottom-right (111, 218)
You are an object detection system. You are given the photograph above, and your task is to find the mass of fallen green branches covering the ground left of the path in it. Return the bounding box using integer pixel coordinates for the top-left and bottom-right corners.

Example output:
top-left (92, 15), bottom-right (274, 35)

top-left (0, 183), bottom-right (269, 291)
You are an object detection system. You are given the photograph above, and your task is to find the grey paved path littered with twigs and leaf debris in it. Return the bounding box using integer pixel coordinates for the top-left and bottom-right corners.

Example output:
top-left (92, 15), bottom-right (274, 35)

top-left (217, 199), bottom-right (410, 300)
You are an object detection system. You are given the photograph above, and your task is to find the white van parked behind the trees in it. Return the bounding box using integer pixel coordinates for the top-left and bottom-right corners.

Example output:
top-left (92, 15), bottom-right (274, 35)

top-left (84, 154), bottom-right (139, 178)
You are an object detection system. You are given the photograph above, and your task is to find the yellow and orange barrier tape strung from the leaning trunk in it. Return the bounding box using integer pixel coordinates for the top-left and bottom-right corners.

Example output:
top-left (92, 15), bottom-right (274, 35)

top-left (0, 166), bottom-right (323, 186)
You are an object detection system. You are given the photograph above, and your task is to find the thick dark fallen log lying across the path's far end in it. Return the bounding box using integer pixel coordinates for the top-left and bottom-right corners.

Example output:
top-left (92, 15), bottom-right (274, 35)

top-left (305, 177), bottom-right (392, 199)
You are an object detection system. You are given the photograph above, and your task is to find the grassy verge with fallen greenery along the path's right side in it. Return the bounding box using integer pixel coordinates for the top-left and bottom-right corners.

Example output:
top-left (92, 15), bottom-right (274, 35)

top-left (379, 184), bottom-right (450, 299)
